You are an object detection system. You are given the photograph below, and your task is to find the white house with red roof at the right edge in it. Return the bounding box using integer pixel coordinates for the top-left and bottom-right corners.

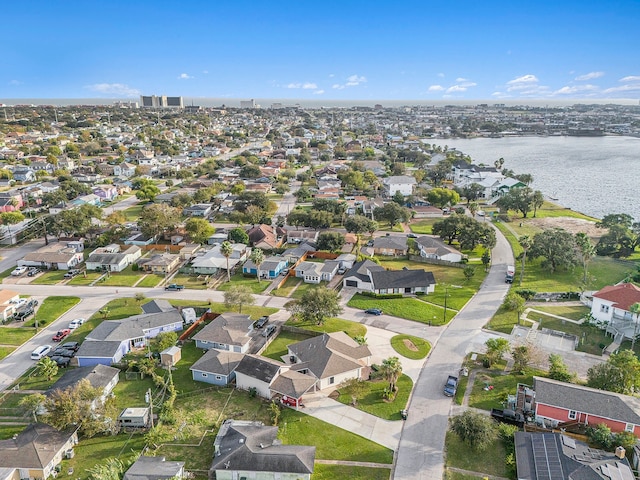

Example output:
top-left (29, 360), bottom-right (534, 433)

top-left (591, 283), bottom-right (640, 340)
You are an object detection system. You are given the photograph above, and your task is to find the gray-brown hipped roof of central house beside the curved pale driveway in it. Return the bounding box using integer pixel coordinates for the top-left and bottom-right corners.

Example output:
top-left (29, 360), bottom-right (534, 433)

top-left (288, 332), bottom-right (371, 378)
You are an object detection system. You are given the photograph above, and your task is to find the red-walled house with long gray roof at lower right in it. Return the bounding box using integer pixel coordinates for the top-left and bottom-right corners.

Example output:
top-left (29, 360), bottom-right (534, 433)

top-left (516, 377), bottom-right (640, 436)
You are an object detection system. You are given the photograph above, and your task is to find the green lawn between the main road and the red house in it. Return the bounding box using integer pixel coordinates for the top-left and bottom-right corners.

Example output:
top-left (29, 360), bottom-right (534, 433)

top-left (469, 370), bottom-right (546, 410)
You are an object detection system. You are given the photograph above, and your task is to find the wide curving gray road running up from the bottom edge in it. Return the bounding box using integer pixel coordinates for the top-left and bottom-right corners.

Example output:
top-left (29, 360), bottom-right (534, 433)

top-left (394, 223), bottom-right (513, 480)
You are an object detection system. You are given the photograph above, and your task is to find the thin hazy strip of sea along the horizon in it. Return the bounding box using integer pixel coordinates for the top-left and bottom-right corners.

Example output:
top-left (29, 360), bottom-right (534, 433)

top-left (0, 94), bottom-right (640, 110)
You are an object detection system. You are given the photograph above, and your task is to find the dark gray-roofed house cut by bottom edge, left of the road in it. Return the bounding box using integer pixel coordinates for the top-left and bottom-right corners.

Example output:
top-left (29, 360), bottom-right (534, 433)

top-left (209, 420), bottom-right (316, 480)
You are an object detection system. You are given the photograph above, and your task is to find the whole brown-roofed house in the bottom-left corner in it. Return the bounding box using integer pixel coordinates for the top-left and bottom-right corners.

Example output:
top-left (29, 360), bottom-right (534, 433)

top-left (0, 423), bottom-right (78, 480)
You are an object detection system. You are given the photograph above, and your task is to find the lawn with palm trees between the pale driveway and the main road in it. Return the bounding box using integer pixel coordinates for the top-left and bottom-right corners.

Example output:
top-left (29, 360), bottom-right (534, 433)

top-left (338, 375), bottom-right (413, 420)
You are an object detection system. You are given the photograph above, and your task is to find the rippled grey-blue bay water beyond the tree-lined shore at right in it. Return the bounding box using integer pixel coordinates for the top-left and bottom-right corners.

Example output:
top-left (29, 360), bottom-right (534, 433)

top-left (428, 136), bottom-right (640, 221)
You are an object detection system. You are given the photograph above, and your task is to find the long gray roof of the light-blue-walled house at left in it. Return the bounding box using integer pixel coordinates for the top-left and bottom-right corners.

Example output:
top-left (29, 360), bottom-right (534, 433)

top-left (87, 309), bottom-right (182, 341)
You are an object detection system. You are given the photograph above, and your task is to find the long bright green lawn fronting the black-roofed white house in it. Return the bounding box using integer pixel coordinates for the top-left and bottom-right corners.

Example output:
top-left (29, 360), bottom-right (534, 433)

top-left (347, 294), bottom-right (457, 325)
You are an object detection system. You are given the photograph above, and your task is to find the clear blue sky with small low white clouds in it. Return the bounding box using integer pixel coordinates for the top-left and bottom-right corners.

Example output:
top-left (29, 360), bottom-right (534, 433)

top-left (5, 0), bottom-right (640, 101)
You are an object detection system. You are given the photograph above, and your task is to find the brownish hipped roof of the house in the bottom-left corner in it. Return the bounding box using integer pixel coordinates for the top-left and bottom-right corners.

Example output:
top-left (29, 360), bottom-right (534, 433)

top-left (0, 423), bottom-right (73, 469)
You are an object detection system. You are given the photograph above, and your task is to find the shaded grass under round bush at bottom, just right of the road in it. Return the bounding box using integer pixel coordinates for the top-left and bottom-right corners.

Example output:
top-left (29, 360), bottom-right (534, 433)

top-left (445, 431), bottom-right (509, 479)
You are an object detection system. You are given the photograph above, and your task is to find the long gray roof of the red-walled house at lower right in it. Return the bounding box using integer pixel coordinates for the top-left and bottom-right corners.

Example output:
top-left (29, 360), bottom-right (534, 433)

top-left (533, 377), bottom-right (640, 425)
